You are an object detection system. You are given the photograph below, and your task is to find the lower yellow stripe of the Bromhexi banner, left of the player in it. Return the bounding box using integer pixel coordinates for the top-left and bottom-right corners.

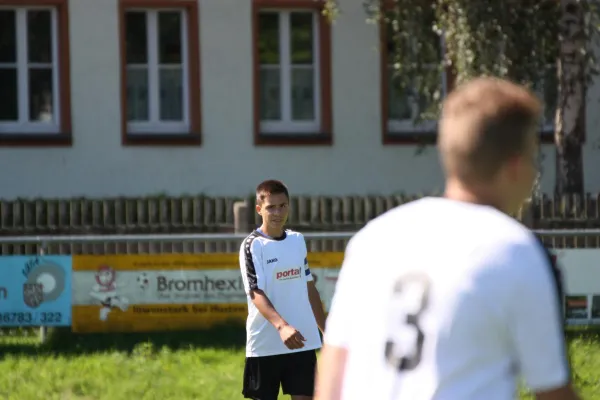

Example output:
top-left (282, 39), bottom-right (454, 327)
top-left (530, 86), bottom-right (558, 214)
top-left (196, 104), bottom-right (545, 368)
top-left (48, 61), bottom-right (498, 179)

top-left (72, 304), bottom-right (248, 333)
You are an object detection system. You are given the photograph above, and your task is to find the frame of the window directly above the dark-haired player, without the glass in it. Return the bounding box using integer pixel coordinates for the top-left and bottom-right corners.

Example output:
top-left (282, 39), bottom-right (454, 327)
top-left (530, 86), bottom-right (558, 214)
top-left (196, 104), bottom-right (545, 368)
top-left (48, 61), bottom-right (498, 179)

top-left (252, 0), bottom-right (333, 145)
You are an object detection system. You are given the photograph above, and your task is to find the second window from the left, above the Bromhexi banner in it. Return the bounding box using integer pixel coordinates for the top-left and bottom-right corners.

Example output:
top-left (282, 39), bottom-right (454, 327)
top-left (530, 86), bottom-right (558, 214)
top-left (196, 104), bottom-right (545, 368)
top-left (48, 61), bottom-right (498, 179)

top-left (123, 0), bottom-right (200, 144)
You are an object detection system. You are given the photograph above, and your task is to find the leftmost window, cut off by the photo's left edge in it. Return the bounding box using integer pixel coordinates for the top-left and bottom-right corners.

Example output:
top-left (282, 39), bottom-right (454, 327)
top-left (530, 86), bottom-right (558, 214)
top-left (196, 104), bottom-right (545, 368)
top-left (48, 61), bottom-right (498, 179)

top-left (0, 1), bottom-right (70, 144)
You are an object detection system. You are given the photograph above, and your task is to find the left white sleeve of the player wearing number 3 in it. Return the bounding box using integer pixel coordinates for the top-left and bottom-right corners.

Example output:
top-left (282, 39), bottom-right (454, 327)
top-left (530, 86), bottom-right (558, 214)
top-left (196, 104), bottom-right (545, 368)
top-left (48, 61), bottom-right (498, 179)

top-left (323, 239), bottom-right (362, 348)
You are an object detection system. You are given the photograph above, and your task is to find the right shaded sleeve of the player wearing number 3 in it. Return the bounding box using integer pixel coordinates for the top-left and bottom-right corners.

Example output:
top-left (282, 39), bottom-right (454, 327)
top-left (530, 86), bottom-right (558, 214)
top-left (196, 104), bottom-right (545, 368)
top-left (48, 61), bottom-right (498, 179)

top-left (508, 239), bottom-right (570, 392)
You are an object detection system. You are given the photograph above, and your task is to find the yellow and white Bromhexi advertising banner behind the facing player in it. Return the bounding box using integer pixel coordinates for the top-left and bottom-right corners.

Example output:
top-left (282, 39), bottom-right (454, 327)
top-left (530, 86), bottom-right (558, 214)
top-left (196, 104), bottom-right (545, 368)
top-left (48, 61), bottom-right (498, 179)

top-left (72, 253), bottom-right (343, 332)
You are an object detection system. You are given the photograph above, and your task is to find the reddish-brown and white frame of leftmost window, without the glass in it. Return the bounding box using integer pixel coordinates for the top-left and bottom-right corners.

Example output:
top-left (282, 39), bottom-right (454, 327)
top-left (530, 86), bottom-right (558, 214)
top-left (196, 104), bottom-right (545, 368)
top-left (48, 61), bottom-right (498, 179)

top-left (0, 0), bottom-right (72, 147)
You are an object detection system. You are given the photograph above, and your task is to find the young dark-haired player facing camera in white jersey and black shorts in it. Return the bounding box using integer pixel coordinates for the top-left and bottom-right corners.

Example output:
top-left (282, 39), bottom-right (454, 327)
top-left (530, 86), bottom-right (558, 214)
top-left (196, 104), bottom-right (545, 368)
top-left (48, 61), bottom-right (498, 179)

top-left (240, 180), bottom-right (325, 400)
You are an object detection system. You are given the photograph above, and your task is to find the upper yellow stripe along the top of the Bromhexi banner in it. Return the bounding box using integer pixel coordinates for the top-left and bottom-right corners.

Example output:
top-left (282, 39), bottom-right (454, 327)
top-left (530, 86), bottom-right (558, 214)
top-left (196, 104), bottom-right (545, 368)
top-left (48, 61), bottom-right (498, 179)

top-left (73, 252), bottom-right (344, 271)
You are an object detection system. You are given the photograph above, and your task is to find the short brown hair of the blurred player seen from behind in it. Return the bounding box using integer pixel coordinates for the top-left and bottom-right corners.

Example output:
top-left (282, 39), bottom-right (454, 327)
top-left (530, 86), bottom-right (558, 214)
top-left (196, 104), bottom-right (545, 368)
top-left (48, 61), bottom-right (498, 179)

top-left (438, 77), bottom-right (542, 180)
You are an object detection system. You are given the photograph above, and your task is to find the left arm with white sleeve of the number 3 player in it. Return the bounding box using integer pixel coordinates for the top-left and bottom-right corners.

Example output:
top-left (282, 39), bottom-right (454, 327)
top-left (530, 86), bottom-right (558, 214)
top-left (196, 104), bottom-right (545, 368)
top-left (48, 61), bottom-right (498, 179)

top-left (315, 239), bottom-right (361, 400)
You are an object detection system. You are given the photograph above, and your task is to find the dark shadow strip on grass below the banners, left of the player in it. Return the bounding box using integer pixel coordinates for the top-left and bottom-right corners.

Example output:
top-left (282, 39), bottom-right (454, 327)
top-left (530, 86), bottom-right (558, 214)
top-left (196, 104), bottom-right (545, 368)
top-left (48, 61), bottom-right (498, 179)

top-left (0, 323), bottom-right (246, 360)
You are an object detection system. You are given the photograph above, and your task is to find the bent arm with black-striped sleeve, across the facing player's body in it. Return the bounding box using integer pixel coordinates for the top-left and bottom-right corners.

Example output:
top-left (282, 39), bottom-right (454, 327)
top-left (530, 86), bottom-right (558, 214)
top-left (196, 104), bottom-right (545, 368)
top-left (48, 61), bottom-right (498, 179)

top-left (240, 240), bottom-right (306, 349)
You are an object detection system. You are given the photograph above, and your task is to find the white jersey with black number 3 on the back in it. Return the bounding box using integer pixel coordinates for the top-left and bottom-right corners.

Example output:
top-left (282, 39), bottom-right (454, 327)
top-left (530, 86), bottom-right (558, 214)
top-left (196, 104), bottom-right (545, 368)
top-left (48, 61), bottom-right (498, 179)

top-left (325, 198), bottom-right (570, 400)
